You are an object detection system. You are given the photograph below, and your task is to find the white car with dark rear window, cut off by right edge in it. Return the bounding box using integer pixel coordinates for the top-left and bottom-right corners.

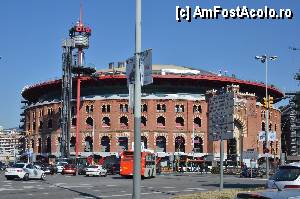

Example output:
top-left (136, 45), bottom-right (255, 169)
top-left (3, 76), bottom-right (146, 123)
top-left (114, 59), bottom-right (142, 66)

top-left (266, 162), bottom-right (300, 190)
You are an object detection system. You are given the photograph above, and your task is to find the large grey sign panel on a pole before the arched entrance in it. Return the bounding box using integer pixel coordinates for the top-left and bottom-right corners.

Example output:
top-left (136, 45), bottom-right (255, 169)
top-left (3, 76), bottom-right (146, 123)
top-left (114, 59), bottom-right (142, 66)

top-left (208, 92), bottom-right (234, 141)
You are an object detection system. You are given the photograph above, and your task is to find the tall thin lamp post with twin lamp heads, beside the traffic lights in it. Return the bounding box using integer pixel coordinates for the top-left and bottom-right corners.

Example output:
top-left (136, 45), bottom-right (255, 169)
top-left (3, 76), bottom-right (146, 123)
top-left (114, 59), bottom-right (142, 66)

top-left (255, 54), bottom-right (277, 179)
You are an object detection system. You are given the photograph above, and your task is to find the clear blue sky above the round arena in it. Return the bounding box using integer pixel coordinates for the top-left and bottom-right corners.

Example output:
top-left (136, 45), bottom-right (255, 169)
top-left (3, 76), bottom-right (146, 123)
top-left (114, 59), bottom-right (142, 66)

top-left (0, 0), bottom-right (300, 128)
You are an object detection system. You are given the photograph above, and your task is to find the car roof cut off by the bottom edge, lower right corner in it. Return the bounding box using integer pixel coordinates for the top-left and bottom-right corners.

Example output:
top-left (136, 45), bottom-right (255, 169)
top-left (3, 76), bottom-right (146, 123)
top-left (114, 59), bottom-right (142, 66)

top-left (235, 190), bottom-right (300, 199)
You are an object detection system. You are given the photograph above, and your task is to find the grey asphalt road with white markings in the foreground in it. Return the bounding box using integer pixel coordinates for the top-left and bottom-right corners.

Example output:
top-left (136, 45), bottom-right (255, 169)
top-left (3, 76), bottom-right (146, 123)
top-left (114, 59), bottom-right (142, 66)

top-left (0, 173), bottom-right (266, 199)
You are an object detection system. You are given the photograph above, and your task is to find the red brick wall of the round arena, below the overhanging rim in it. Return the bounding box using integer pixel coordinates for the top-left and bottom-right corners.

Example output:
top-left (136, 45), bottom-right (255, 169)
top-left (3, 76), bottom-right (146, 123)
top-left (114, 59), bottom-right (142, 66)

top-left (25, 89), bottom-right (281, 159)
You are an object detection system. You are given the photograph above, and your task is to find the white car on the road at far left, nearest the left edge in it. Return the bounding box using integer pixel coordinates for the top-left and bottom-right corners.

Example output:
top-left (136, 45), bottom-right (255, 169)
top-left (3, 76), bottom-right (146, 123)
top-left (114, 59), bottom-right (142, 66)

top-left (4, 163), bottom-right (46, 180)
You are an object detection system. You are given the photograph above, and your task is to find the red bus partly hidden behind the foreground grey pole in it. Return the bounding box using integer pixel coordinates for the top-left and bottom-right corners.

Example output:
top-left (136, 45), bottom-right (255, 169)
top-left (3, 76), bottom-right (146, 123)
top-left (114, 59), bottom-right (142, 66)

top-left (120, 151), bottom-right (156, 178)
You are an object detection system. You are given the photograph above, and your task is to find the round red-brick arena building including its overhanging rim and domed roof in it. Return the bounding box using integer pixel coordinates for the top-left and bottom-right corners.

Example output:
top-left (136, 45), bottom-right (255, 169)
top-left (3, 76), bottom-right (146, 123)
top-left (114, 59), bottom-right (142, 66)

top-left (22, 65), bottom-right (283, 161)
